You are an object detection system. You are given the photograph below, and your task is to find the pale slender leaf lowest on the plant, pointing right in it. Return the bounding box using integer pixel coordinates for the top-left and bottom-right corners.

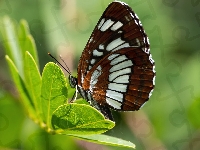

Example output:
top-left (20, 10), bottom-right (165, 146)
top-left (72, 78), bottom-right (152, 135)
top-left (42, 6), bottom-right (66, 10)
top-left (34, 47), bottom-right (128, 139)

top-left (69, 134), bottom-right (135, 149)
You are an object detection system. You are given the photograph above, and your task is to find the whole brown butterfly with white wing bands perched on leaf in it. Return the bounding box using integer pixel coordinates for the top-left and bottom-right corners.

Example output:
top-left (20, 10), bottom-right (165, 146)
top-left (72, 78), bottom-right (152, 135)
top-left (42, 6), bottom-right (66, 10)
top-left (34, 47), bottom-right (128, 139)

top-left (49, 1), bottom-right (155, 120)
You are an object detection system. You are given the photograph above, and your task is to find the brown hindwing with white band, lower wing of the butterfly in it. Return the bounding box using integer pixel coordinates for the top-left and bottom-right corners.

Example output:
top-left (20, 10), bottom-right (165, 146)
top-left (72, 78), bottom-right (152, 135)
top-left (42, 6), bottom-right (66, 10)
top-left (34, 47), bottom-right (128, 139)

top-left (83, 47), bottom-right (155, 111)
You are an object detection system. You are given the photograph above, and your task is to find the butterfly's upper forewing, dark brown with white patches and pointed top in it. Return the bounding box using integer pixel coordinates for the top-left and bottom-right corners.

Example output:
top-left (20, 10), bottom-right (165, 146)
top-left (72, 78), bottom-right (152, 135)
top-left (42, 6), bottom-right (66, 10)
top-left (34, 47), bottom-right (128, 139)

top-left (78, 1), bottom-right (149, 86)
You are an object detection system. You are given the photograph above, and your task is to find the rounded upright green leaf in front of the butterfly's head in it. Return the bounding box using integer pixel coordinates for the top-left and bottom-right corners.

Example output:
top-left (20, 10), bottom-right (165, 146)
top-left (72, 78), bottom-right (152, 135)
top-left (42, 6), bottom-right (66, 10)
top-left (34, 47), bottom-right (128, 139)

top-left (40, 62), bottom-right (67, 128)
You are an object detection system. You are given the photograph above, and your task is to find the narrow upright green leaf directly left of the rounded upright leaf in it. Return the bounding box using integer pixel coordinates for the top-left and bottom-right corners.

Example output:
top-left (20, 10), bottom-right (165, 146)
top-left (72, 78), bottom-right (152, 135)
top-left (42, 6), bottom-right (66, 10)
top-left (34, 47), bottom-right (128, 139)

top-left (24, 51), bottom-right (42, 120)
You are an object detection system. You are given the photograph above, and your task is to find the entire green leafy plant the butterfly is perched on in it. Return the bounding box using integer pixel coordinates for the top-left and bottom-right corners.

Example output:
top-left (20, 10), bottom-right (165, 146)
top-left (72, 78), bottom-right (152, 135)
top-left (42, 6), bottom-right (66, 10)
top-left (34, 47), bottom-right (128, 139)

top-left (1, 17), bottom-right (135, 148)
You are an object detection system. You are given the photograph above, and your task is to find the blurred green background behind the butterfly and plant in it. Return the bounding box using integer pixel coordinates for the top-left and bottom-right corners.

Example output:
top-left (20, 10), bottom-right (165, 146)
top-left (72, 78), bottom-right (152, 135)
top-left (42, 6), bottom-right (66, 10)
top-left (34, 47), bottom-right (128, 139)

top-left (0, 0), bottom-right (200, 150)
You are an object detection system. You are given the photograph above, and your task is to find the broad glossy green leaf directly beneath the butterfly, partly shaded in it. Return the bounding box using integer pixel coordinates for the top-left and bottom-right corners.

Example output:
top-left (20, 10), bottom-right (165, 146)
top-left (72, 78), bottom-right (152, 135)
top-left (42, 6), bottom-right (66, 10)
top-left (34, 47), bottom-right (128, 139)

top-left (52, 103), bottom-right (115, 134)
